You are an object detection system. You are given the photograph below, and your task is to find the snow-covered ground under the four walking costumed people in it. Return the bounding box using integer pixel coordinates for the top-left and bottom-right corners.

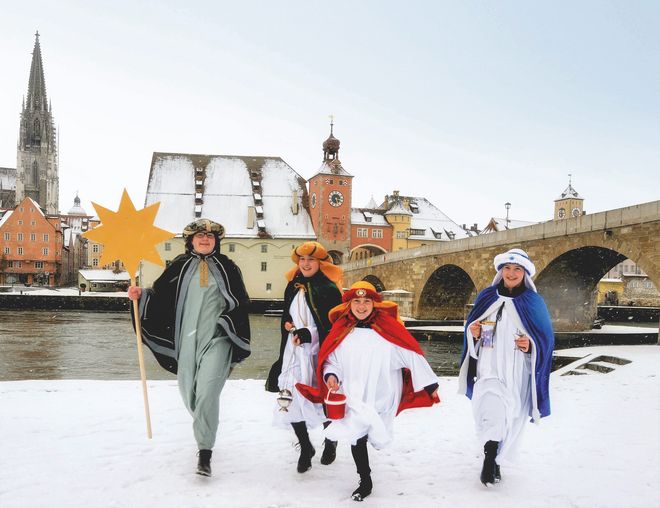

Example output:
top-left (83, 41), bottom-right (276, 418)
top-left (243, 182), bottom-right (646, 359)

top-left (0, 346), bottom-right (660, 508)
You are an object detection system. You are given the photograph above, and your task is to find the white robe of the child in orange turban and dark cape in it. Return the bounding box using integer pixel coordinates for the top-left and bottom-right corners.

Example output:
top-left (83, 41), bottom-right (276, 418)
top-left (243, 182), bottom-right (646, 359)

top-left (273, 289), bottom-right (326, 428)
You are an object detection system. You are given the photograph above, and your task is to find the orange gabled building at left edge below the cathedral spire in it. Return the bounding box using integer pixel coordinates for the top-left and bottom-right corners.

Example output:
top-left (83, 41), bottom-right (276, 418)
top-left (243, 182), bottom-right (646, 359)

top-left (0, 197), bottom-right (62, 286)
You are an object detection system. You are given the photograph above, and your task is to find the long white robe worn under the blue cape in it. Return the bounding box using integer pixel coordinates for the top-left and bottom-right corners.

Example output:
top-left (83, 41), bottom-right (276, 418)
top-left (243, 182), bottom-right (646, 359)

top-left (463, 295), bottom-right (538, 462)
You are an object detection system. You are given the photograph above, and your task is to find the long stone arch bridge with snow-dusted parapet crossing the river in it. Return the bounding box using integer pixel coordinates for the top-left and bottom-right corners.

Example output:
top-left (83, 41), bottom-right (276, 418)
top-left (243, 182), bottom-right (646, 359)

top-left (343, 201), bottom-right (660, 330)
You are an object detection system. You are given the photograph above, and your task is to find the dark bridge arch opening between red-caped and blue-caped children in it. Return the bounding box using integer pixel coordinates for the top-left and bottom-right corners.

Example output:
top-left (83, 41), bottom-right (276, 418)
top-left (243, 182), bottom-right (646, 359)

top-left (416, 264), bottom-right (477, 319)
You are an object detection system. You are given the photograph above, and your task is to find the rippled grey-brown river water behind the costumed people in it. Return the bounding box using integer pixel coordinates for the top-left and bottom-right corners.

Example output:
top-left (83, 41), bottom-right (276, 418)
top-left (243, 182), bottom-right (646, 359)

top-left (0, 310), bottom-right (462, 381)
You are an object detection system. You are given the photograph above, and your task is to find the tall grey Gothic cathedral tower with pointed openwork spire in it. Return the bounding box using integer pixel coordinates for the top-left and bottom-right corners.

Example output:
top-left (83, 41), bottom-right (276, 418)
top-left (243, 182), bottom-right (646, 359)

top-left (16, 32), bottom-right (59, 213)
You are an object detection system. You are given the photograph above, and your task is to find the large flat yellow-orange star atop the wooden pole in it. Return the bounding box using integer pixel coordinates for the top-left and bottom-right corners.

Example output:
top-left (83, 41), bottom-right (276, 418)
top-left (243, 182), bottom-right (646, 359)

top-left (82, 189), bottom-right (174, 280)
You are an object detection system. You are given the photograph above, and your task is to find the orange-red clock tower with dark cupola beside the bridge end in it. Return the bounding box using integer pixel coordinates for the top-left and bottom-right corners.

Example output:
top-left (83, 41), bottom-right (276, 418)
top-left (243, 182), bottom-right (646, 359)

top-left (308, 120), bottom-right (353, 264)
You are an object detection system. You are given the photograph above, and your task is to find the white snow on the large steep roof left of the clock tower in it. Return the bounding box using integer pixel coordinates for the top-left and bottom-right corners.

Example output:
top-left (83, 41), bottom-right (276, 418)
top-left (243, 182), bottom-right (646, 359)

top-left (145, 152), bottom-right (316, 239)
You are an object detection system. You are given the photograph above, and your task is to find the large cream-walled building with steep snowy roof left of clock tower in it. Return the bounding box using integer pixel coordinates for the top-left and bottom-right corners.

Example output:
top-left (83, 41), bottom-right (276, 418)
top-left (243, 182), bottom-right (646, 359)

top-left (140, 152), bottom-right (316, 300)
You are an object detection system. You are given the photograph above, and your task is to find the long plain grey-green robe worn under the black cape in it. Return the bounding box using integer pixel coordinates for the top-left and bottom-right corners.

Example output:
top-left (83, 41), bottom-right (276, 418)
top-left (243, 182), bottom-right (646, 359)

top-left (177, 263), bottom-right (232, 450)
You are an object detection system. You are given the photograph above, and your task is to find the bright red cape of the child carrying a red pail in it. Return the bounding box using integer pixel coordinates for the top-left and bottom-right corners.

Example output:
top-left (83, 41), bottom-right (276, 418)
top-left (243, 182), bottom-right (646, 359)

top-left (296, 304), bottom-right (440, 415)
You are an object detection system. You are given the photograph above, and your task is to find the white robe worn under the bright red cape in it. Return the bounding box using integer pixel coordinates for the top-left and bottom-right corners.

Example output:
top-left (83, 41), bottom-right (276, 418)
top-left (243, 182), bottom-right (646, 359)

top-left (323, 328), bottom-right (438, 449)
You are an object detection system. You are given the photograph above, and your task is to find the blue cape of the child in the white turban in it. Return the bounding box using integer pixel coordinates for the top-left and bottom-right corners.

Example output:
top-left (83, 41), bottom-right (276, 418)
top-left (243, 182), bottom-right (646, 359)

top-left (460, 285), bottom-right (555, 417)
